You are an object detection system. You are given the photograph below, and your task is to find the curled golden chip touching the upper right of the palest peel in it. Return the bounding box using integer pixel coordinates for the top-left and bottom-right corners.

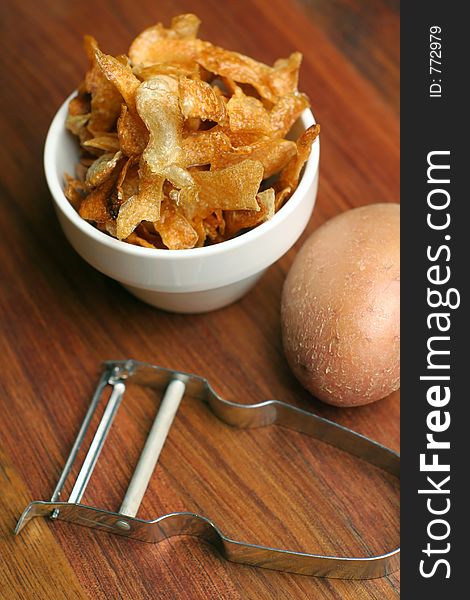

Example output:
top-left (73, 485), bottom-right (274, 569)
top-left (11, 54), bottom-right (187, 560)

top-left (179, 77), bottom-right (227, 124)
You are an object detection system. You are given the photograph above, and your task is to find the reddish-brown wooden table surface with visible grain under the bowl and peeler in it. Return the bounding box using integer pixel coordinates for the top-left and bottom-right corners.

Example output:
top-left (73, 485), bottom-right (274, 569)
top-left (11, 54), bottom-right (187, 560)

top-left (0, 0), bottom-right (399, 600)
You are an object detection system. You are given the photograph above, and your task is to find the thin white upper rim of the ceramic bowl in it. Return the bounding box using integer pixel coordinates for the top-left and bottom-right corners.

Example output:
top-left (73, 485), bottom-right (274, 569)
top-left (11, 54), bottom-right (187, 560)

top-left (44, 90), bottom-right (320, 260)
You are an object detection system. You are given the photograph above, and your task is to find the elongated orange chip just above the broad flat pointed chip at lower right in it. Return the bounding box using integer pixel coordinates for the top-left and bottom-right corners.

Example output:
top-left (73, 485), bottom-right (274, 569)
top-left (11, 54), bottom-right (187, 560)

top-left (211, 137), bottom-right (297, 179)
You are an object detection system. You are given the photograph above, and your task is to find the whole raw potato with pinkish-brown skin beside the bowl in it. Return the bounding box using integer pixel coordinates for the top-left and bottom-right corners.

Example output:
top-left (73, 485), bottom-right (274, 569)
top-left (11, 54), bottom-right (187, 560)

top-left (281, 204), bottom-right (400, 406)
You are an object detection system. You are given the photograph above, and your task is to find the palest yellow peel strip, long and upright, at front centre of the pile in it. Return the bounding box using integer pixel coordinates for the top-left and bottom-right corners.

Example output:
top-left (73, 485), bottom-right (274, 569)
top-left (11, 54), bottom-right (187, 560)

top-left (136, 75), bottom-right (193, 188)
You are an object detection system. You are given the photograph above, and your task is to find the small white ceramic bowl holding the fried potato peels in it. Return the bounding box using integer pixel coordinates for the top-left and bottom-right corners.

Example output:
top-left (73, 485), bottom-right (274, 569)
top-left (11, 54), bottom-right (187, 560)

top-left (44, 95), bottom-right (320, 313)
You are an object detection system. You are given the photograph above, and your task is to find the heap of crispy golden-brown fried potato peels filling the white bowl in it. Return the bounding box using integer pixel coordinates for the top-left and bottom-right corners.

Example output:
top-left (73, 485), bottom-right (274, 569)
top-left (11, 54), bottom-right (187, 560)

top-left (65, 14), bottom-right (319, 250)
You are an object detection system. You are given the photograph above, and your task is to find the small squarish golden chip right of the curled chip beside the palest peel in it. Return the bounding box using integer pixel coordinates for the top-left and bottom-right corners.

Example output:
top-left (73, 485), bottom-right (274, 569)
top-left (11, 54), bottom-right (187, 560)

top-left (227, 88), bottom-right (271, 135)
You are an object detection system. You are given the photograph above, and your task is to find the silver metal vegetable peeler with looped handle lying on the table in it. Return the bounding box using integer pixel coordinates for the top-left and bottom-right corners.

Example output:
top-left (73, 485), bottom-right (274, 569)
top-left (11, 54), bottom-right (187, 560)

top-left (15, 360), bottom-right (400, 579)
